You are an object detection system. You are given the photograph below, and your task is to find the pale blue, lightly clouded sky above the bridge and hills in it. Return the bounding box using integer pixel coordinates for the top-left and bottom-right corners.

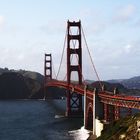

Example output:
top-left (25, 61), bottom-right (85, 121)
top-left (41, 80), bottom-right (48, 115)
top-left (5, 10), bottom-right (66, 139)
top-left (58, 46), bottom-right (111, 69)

top-left (0, 0), bottom-right (140, 80)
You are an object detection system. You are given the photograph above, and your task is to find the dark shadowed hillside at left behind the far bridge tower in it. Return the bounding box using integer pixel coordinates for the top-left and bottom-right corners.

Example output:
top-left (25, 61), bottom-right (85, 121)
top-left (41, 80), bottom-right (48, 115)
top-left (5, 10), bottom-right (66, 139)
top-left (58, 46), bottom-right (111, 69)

top-left (0, 68), bottom-right (65, 99)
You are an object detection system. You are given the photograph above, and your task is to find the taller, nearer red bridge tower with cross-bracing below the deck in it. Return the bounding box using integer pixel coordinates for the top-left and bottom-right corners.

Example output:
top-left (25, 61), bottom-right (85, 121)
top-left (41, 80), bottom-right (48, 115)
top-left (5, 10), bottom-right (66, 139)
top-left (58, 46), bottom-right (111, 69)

top-left (66, 21), bottom-right (83, 116)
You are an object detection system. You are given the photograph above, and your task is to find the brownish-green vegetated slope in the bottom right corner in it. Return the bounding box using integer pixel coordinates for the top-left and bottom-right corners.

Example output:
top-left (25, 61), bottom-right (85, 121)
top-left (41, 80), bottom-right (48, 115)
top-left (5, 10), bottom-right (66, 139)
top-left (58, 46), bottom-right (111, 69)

top-left (97, 113), bottom-right (140, 140)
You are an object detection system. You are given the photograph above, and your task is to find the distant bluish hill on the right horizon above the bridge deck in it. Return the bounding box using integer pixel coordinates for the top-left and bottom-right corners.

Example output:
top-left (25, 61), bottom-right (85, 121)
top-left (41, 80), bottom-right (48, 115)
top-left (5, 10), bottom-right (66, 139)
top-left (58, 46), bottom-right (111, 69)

top-left (107, 76), bottom-right (140, 89)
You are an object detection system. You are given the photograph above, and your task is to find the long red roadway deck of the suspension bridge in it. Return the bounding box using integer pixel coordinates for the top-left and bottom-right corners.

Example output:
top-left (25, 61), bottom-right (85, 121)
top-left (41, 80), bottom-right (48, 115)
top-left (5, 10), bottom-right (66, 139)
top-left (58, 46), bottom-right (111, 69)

top-left (46, 81), bottom-right (140, 109)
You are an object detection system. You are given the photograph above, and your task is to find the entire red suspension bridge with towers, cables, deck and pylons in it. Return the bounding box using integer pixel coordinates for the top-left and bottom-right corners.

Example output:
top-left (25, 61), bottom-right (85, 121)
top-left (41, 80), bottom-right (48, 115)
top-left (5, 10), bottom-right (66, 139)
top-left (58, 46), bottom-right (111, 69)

top-left (44, 21), bottom-right (140, 133)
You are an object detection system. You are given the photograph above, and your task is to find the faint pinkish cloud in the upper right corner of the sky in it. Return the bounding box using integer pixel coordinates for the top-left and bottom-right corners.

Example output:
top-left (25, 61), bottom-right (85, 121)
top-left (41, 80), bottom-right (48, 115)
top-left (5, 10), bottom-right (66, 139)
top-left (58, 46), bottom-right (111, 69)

top-left (113, 4), bottom-right (136, 22)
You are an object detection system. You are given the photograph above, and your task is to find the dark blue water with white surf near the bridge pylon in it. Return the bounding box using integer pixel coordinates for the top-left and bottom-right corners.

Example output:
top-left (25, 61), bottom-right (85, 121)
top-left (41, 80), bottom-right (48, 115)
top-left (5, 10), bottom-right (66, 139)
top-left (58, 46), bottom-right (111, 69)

top-left (0, 100), bottom-right (89, 140)
